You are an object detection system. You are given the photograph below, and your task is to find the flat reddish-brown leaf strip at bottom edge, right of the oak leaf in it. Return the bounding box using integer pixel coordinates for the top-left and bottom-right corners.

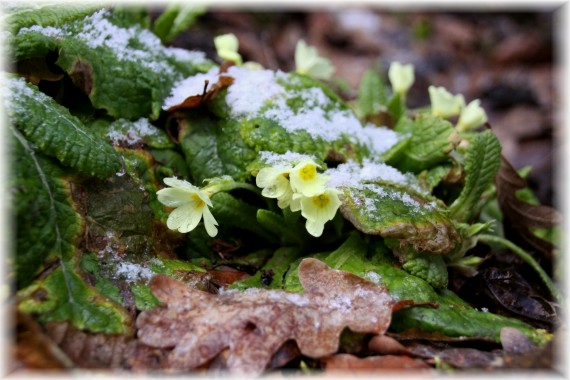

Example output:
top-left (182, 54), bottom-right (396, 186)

top-left (325, 354), bottom-right (431, 374)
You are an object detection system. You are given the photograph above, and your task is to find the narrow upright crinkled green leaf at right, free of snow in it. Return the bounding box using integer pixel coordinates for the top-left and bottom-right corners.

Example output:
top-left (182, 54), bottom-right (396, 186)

top-left (449, 130), bottom-right (501, 222)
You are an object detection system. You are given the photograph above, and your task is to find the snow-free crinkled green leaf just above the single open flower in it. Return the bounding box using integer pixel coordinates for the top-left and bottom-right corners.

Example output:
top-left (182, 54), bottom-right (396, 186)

top-left (180, 112), bottom-right (257, 186)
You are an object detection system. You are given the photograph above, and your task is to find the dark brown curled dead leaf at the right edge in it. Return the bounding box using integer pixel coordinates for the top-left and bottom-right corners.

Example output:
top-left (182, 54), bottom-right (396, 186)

top-left (496, 156), bottom-right (562, 259)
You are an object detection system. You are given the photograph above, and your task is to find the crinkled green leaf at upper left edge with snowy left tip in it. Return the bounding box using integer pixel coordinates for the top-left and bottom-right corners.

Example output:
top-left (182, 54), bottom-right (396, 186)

top-left (6, 77), bottom-right (121, 178)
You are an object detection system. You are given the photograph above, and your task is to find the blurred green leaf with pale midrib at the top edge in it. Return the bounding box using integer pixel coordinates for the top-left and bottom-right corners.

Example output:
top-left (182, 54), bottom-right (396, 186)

top-left (152, 4), bottom-right (206, 42)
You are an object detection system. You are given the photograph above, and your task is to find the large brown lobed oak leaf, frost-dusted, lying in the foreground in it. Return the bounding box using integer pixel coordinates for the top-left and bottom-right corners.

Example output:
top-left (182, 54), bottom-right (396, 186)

top-left (136, 258), bottom-right (394, 375)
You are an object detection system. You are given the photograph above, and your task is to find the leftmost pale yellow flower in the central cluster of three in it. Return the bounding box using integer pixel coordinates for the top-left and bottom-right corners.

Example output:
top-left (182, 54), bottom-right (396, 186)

top-left (255, 166), bottom-right (293, 208)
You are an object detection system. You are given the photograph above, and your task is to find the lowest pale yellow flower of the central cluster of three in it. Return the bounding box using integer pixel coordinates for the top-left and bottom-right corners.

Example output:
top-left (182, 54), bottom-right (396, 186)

top-left (296, 188), bottom-right (341, 237)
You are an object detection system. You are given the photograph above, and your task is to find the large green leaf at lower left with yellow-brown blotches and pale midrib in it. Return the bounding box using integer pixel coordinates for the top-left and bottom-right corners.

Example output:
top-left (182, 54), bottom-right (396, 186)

top-left (13, 130), bottom-right (131, 333)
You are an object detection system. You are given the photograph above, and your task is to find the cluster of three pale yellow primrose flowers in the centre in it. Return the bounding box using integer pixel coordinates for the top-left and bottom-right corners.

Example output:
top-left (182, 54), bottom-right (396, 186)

top-left (255, 159), bottom-right (340, 237)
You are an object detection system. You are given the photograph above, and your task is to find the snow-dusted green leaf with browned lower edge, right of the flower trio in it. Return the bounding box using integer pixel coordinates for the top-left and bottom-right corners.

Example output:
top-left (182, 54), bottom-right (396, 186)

top-left (340, 183), bottom-right (460, 253)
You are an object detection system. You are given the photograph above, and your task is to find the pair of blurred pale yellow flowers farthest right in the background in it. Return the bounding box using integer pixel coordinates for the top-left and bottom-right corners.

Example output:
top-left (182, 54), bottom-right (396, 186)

top-left (428, 86), bottom-right (487, 132)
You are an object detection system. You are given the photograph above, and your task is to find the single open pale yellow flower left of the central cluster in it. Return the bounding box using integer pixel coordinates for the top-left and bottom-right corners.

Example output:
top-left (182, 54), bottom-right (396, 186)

top-left (156, 177), bottom-right (218, 237)
